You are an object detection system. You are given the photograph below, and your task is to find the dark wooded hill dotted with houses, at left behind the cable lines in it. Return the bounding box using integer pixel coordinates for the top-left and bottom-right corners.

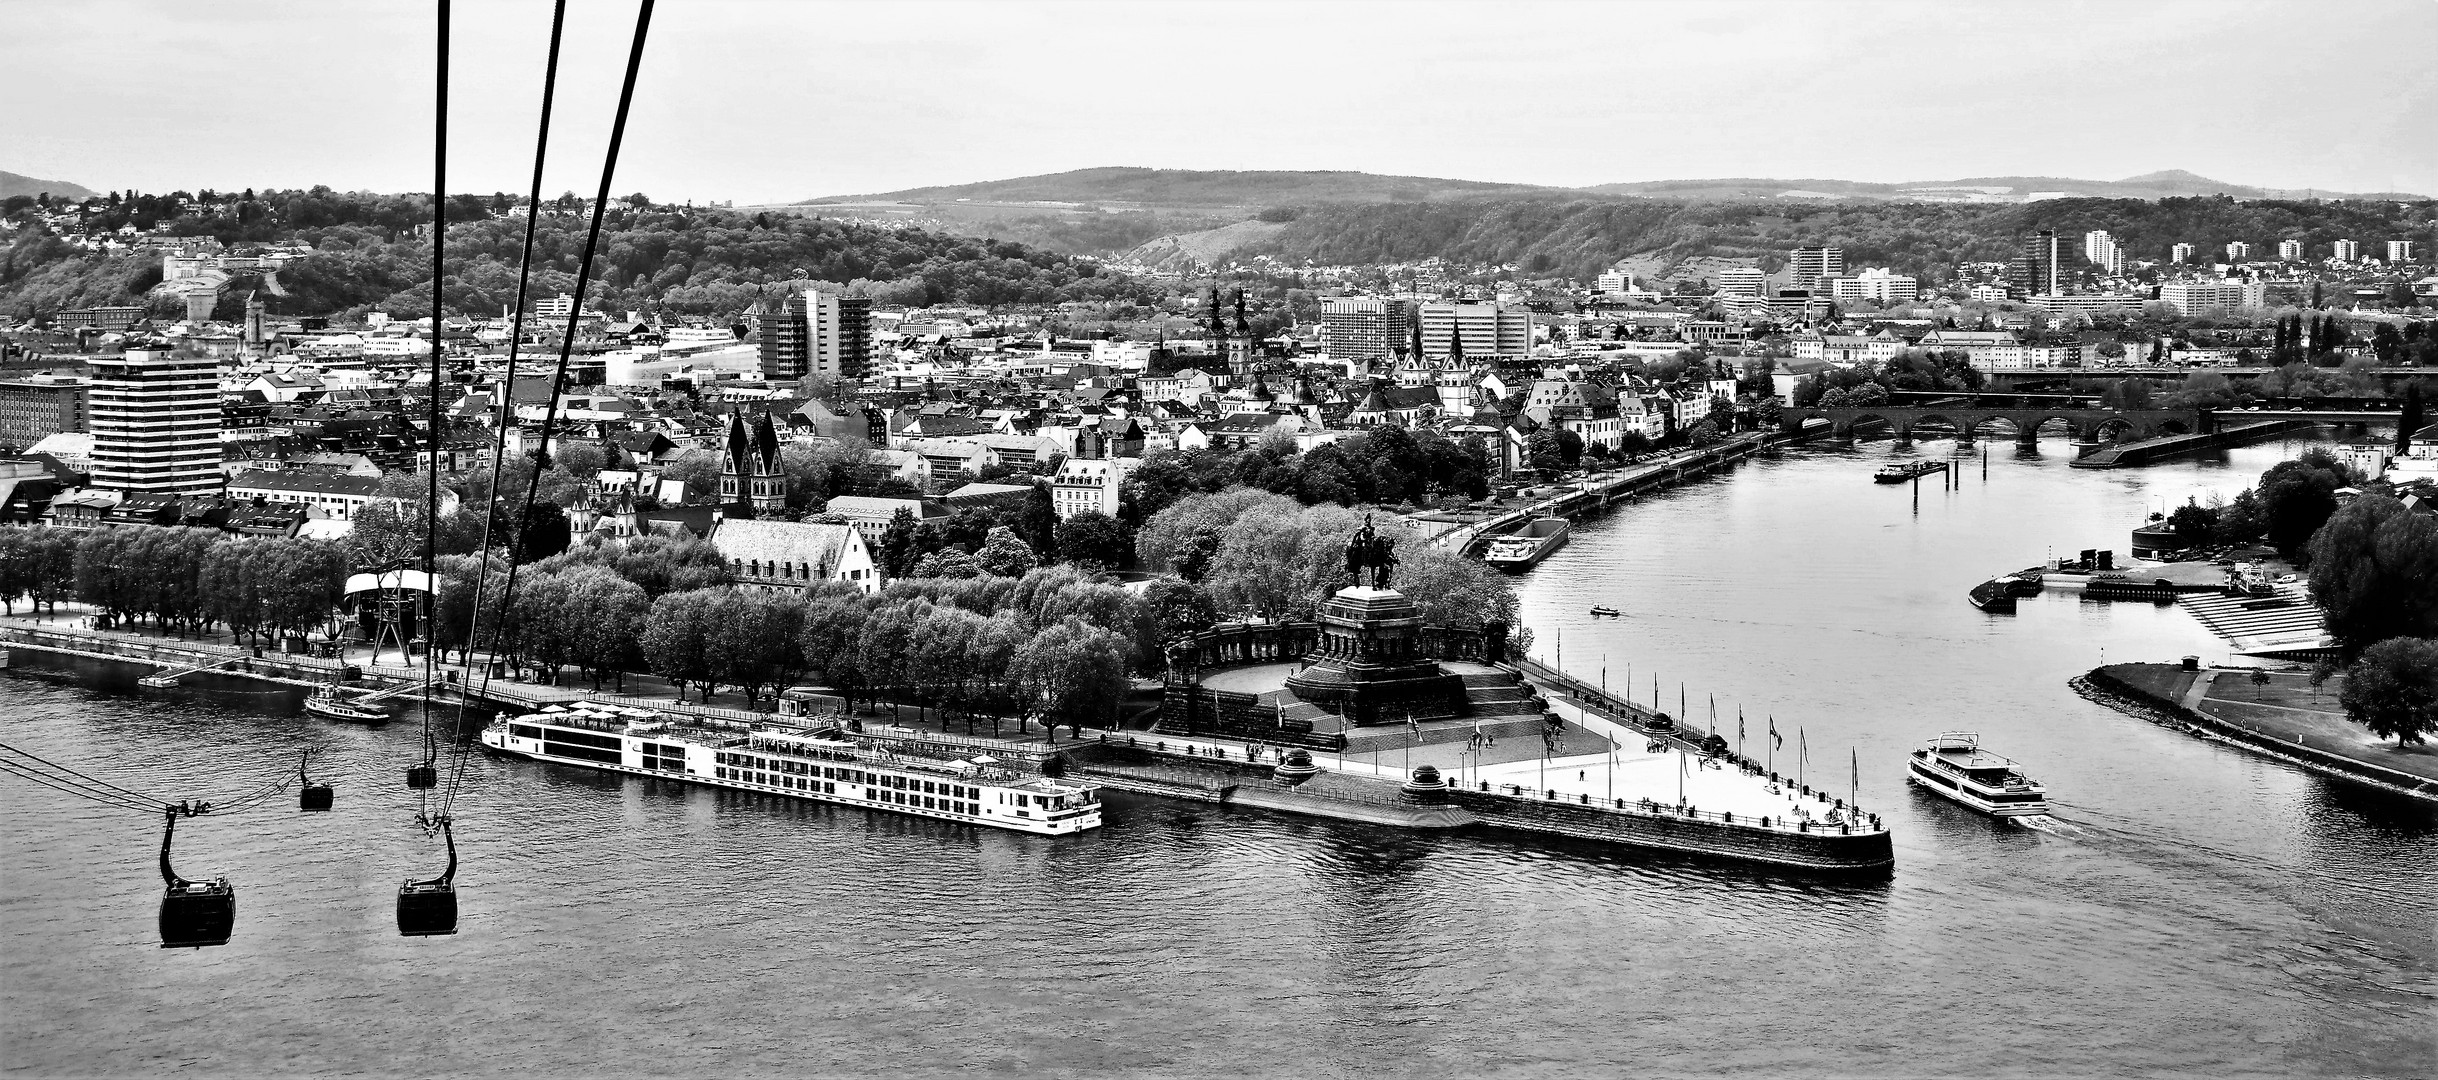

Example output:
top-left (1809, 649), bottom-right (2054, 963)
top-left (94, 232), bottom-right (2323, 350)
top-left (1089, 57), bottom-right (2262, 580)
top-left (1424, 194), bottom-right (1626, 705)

top-left (0, 188), bottom-right (1141, 319)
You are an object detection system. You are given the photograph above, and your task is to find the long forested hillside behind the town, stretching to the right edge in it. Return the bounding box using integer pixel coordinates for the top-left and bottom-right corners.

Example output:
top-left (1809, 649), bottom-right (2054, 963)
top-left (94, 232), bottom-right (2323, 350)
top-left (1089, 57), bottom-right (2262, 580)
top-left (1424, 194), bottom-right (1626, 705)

top-left (1234, 197), bottom-right (2433, 278)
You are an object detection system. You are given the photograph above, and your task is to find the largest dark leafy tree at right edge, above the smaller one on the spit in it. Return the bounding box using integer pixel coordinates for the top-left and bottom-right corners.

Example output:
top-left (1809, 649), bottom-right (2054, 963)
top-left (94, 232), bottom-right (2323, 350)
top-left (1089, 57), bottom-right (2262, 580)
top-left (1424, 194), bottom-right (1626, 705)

top-left (2311, 495), bottom-right (2438, 656)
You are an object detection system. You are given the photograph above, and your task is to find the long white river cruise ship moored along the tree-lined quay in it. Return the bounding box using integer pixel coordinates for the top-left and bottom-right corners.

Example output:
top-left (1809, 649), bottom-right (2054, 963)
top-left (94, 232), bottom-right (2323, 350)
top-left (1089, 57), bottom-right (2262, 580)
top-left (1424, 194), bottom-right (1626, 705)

top-left (480, 702), bottom-right (1100, 836)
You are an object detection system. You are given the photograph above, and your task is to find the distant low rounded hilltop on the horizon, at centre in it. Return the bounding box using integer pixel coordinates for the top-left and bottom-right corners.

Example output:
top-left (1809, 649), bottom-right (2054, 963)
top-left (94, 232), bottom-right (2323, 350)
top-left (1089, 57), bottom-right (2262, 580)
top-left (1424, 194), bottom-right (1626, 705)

top-left (807, 166), bottom-right (1560, 210)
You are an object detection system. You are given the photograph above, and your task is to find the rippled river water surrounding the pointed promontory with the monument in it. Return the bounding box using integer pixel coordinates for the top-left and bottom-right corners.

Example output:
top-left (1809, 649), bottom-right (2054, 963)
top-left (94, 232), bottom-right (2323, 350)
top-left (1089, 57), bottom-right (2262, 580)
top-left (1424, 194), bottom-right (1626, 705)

top-left (0, 441), bottom-right (2438, 1078)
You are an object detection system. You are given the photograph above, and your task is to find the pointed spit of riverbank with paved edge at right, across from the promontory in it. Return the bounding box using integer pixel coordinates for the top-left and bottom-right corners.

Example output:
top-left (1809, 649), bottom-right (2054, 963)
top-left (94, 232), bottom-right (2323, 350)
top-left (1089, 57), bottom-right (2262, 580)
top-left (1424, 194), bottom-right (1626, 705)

top-left (2072, 663), bottom-right (2438, 802)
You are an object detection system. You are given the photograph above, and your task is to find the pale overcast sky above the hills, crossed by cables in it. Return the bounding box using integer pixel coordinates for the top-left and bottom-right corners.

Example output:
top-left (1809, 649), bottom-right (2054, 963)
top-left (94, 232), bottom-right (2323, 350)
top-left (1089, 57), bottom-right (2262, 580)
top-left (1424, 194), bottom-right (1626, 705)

top-left (0, 0), bottom-right (2438, 205)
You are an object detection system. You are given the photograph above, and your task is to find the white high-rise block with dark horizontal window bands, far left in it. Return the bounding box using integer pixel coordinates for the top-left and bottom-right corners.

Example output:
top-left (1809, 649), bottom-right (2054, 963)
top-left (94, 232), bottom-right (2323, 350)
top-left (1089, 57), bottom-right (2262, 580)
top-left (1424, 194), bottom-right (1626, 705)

top-left (88, 349), bottom-right (222, 492)
